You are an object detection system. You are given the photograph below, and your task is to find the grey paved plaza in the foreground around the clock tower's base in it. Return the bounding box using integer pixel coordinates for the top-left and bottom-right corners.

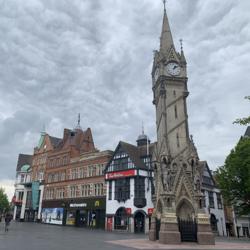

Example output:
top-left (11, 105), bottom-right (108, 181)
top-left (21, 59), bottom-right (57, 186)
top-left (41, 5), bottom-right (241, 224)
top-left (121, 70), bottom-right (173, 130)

top-left (0, 222), bottom-right (250, 250)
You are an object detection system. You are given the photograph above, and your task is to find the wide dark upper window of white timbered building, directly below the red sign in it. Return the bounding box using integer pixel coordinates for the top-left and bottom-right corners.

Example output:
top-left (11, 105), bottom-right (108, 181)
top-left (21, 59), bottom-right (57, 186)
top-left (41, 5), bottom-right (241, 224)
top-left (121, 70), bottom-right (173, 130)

top-left (115, 178), bottom-right (130, 201)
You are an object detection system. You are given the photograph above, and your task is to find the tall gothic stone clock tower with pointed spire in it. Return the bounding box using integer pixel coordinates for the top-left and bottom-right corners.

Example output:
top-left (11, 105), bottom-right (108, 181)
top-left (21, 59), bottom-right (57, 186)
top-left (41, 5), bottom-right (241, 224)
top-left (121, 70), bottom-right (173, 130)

top-left (149, 8), bottom-right (214, 244)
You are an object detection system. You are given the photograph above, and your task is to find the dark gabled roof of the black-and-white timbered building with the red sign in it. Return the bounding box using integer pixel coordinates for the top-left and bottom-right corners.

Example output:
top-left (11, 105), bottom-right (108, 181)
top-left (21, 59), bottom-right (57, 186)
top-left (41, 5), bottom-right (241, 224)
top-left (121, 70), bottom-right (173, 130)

top-left (105, 141), bottom-right (154, 171)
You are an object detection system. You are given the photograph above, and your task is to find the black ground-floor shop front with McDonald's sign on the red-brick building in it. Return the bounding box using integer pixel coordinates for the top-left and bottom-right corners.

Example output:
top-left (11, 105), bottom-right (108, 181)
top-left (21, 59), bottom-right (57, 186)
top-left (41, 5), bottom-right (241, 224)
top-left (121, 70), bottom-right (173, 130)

top-left (42, 198), bottom-right (106, 229)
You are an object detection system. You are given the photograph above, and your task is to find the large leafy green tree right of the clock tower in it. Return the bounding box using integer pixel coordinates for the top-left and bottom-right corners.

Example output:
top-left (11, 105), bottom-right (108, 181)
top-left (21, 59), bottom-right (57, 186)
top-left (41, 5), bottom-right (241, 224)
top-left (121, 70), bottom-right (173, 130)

top-left (216, 137), bottom-right (250, 215)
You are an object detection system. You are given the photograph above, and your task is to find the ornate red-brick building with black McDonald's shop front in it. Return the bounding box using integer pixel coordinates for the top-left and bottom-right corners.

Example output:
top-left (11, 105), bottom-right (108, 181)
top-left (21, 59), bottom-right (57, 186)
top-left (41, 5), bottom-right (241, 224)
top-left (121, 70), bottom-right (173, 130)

top-left (42, 126), bottom-right (112, 228)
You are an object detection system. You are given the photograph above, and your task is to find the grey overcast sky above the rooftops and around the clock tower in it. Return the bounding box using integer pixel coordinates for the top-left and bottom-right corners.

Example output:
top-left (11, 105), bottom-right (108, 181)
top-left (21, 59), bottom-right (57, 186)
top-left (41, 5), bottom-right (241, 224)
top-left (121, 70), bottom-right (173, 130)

top-left (0, 0), bottom-right (250, 199)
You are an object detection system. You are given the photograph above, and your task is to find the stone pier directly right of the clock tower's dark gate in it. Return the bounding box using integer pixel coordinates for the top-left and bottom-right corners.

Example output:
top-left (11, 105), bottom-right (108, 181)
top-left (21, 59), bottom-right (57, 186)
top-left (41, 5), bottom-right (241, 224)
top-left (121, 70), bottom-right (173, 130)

top-left (197, 213), bottom-right (215, 245)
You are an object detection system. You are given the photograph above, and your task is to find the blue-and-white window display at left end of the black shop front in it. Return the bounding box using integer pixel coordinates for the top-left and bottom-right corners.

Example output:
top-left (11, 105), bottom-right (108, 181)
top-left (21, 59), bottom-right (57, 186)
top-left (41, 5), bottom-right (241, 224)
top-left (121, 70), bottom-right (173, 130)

top-left (42, 207), bottom-right (63, 225)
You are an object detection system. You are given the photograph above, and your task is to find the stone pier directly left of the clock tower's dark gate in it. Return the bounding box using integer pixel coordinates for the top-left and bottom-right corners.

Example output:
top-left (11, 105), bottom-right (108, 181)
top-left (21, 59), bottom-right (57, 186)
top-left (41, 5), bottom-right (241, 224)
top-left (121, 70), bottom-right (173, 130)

top-left (159, 213), bottom-right (181, 244)
